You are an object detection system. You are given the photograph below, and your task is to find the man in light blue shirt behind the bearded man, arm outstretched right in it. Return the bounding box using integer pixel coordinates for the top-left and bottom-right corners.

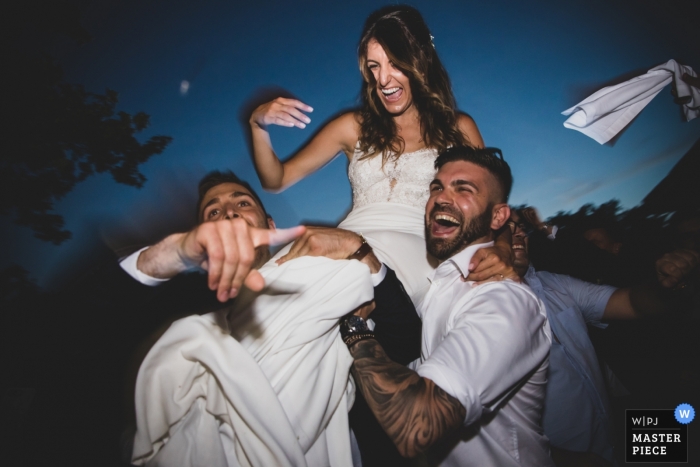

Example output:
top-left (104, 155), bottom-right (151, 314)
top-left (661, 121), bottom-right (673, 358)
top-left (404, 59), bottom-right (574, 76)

top-left (509, 211), bottom-right (700, 465)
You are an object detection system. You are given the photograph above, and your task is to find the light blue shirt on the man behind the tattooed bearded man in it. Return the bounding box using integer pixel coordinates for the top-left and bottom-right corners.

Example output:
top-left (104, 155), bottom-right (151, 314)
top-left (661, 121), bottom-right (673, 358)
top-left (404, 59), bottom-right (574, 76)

top-left (525, 266), bottom-right (616, 462)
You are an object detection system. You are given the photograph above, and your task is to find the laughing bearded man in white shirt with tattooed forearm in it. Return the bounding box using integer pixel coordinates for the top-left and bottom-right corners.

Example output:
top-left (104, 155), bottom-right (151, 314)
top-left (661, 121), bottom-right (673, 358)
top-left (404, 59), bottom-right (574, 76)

top-left (341, 147), bottom-right (553, 467)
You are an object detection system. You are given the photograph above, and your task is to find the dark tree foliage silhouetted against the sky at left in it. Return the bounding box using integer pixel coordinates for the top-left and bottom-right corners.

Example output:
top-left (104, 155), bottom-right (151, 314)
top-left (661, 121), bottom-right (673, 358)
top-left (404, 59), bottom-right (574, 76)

top-left (0, 2), bottom-right (172, 244)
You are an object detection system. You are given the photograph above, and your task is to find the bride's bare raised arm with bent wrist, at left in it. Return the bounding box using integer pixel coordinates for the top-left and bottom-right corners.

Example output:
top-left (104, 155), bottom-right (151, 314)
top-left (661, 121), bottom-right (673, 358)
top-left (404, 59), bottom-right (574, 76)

top-left (249, 97), bottom-right (359, 192)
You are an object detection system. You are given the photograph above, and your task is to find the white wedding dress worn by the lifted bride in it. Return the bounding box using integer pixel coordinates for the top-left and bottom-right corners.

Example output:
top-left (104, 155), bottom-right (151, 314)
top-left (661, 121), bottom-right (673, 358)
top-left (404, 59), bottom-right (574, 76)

top-left (338, 148), bottom-right (437, 304)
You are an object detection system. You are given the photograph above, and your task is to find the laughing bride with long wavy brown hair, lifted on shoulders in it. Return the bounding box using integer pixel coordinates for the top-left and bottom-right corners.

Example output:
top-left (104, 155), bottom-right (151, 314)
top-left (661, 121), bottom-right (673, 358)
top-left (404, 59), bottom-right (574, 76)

top-left (250, 5), bottom-right (484, 303)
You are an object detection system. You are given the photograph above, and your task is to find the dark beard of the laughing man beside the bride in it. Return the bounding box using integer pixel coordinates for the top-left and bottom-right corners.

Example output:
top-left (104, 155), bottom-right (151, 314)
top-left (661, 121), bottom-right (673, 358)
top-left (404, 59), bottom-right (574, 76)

top-left (425, 203), bottom-right (493, 260)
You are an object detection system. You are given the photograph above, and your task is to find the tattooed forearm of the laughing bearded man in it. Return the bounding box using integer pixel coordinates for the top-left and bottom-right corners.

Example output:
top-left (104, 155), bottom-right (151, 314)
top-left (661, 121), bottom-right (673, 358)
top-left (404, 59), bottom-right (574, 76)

top-left (350, 339), bottom-right (466, 457)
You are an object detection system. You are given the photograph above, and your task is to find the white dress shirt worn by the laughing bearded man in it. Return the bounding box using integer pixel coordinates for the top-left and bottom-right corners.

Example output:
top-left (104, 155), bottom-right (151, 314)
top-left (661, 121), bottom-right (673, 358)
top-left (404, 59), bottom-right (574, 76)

top-left (416, 242), bottom-right (553, 467)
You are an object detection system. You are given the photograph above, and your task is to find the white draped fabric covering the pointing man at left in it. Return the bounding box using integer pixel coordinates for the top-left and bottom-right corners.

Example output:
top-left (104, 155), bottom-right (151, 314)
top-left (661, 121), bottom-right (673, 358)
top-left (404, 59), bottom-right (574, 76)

top-left (132, 253), bottom-right (373, 467)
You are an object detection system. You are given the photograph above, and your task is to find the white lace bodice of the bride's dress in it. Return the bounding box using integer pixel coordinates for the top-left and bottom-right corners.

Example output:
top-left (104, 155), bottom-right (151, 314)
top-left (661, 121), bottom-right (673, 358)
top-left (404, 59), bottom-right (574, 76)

top-left (348, 148), bottom-right (437, 209)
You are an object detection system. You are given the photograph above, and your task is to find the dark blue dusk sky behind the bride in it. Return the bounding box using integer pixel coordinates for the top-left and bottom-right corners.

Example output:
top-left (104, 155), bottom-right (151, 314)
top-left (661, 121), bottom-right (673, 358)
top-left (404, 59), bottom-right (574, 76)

top-left (0, 0), bottom-right (700, 285)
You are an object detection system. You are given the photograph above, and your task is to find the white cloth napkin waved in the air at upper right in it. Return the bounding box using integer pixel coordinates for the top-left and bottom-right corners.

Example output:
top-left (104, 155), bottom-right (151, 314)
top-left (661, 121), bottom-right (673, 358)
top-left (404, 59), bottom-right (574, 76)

top-left (562, 60), bottom-right (700, 144)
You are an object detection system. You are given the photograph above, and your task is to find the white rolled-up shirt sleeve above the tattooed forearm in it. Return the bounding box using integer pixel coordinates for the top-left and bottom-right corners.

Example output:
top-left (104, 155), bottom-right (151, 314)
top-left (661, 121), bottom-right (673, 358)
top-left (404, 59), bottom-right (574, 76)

top-left (416, 282), bottom-right (551, 425)
